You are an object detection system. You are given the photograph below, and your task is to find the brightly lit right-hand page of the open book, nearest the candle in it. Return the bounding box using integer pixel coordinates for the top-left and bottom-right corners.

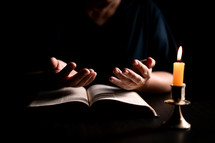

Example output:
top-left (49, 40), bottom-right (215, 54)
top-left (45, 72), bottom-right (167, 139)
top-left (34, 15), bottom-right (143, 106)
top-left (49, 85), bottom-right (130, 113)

top-left (87, 84), bottom-right (157, 116)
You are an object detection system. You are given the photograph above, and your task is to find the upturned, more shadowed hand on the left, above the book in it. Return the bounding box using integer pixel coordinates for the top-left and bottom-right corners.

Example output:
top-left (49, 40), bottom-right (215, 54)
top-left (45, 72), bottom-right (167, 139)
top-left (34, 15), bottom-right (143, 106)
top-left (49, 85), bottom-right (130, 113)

top-left (50, 57), bottom-right (97, 87)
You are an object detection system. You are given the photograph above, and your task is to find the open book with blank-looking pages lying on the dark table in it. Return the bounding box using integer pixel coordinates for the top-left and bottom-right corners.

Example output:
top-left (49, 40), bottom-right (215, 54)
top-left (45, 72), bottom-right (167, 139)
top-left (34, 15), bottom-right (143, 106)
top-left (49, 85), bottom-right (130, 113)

top-left (29, 84), bottom-right (158, 116)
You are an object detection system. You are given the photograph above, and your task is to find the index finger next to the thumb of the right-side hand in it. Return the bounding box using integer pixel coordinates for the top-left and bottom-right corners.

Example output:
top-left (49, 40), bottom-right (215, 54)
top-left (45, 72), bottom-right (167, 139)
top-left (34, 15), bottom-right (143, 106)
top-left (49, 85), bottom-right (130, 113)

top-left (132, 60), bottom-right (149, 77)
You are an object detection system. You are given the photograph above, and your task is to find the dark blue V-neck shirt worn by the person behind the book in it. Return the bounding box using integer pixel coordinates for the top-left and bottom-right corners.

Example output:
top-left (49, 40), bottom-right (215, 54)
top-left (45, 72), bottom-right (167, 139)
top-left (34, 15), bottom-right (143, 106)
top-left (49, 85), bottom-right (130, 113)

top-left (27, 0), bottom-right (176, 82)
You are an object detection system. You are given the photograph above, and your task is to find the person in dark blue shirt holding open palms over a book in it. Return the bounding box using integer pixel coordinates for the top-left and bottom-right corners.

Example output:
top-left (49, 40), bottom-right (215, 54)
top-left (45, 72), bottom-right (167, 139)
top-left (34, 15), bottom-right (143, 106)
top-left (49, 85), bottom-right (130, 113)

top-left (21, 0), bottom-right (177, 98)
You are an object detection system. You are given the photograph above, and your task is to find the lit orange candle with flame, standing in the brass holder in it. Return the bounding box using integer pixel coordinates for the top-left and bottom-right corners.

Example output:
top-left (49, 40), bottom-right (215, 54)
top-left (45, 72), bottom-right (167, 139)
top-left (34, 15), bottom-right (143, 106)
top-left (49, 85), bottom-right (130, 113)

top-left (173, 46), bottom-right (185, 86)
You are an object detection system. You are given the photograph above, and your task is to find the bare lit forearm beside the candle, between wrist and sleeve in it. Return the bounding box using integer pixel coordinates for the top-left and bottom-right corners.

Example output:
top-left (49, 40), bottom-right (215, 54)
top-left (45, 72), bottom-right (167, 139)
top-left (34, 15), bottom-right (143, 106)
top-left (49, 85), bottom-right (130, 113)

top-left (141, 71), bottom-right (173, 93)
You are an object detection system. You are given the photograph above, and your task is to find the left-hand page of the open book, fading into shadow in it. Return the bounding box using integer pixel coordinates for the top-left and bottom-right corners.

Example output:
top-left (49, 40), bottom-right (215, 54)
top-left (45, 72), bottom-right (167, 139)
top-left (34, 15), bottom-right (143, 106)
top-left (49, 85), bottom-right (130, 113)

top-left (29, 87), bottom-right (89, 107)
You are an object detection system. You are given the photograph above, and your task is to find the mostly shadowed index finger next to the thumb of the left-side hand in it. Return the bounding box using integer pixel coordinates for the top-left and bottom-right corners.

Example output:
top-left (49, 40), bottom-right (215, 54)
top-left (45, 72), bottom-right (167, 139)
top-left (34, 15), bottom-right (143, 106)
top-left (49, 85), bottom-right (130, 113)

top-left (58, 62), bottom-right (76, 78)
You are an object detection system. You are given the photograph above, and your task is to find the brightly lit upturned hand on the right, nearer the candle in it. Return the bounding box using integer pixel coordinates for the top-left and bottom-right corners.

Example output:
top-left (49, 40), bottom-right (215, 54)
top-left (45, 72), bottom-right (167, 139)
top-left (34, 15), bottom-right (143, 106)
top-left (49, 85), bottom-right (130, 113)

top-left (109, 57), bottom-right (155, 91)
